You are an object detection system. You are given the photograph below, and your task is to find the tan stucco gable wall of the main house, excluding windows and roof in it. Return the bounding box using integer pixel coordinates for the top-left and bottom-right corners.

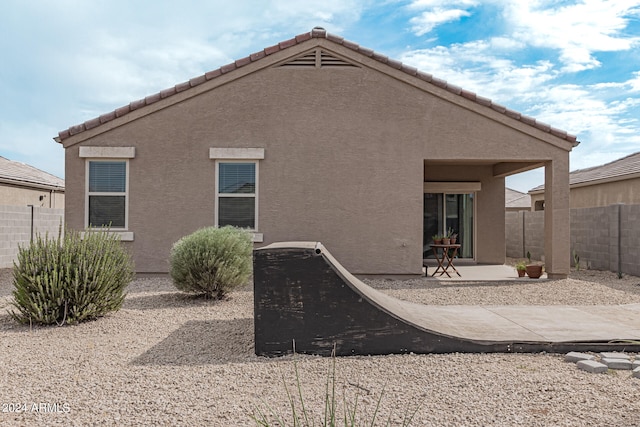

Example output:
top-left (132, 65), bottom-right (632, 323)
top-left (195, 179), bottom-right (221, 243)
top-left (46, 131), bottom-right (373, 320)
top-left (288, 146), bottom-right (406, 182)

top-left (66, 42), bottom-right (568, 274)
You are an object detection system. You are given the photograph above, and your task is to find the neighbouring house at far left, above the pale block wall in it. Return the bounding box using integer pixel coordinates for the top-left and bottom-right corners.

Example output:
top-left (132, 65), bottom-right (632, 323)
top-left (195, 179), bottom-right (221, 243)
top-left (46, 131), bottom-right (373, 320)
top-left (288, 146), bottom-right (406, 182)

top-left (0, 156), bottom-right (64, 208)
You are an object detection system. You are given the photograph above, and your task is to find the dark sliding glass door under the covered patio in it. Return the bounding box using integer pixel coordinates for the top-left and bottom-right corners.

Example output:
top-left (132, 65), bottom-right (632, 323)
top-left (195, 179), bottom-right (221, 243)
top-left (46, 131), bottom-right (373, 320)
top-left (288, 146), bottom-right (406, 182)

top-left (422, 193), bottom-right (474, 258)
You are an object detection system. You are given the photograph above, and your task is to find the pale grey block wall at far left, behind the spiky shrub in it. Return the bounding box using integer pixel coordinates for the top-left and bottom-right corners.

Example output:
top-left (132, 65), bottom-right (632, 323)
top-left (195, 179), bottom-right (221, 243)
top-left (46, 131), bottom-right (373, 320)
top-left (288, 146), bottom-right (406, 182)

top-left (0, 206), bottom-right (64, 268)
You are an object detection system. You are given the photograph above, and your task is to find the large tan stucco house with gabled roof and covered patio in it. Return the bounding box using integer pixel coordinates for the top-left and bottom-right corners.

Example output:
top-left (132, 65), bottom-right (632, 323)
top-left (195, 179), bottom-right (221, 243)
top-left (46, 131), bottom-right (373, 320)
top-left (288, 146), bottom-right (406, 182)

top-left (55, 28), bottom-right (578, 277)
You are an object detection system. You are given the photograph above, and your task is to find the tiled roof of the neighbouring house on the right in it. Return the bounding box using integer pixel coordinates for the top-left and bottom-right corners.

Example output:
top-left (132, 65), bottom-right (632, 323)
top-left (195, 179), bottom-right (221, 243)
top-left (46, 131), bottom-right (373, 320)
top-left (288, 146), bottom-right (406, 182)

top-left (529, 152), bottom-right (640, 194)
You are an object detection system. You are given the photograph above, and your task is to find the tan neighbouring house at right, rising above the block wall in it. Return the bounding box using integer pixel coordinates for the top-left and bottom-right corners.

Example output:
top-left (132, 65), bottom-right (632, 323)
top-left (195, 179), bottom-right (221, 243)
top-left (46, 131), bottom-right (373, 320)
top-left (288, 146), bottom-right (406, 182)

top-left (529, 152), bottom-right (640, 211)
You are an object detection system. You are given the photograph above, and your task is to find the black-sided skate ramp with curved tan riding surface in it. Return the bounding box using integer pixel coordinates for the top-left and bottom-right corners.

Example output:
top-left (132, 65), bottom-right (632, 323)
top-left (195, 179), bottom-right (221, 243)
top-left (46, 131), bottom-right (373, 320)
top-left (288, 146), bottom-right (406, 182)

top-left (253, 242), bottom-right (640, 356)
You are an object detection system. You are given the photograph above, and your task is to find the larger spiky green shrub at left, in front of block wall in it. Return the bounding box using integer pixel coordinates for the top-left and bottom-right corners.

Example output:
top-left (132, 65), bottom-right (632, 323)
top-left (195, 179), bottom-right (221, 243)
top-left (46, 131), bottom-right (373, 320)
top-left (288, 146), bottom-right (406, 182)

top-left (9, 229), bottom-right (133, 325)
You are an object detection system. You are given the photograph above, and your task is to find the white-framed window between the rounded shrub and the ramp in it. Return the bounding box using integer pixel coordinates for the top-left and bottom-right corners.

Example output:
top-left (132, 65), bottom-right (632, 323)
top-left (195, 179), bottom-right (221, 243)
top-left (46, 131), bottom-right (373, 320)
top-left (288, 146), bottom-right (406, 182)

top-left (216, 161), bottom-right (258, 230)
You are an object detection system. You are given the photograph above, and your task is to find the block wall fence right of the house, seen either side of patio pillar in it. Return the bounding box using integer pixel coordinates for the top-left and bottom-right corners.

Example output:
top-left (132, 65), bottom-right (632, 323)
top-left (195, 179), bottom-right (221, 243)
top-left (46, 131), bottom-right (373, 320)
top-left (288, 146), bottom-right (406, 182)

top-left (505, 204), bottom-right (640, 276)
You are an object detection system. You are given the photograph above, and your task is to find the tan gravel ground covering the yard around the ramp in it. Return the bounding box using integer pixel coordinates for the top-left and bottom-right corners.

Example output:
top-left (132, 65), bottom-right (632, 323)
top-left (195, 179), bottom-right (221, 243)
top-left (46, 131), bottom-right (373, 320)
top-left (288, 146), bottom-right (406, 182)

top-left (0, 269), bottom-right (640, 427)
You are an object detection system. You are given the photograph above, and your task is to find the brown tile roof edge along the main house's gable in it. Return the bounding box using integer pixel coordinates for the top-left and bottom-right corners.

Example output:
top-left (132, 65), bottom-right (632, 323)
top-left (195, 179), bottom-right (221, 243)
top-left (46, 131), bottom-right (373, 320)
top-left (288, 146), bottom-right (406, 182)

top-left (55, 27), bottom-right (579, 146)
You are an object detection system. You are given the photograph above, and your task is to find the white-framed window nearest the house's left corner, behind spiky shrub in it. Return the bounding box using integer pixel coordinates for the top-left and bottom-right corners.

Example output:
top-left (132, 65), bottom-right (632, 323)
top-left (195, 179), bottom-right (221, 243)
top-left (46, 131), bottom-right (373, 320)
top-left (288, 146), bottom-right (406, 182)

top-left (86, 160), bottom-right (129, 229)
